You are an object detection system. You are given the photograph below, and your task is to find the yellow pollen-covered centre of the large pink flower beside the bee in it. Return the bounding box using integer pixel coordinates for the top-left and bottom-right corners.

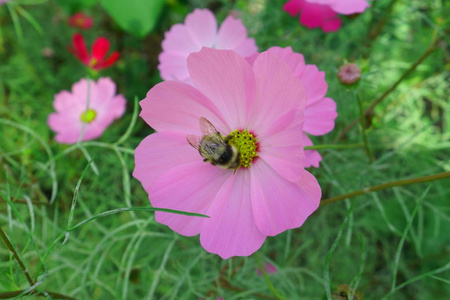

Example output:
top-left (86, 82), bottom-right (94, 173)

top-left (225, 129), bottom-right (258, 168)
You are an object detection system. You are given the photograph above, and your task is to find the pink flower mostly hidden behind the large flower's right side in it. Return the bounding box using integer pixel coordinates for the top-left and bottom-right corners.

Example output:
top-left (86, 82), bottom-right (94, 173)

top-left (247, 47), bottom-right (337, 168)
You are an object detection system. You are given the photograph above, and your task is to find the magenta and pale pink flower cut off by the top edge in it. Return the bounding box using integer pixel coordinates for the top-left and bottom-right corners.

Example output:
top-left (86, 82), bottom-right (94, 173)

top-left (283, 0), bottom-right (369, 32)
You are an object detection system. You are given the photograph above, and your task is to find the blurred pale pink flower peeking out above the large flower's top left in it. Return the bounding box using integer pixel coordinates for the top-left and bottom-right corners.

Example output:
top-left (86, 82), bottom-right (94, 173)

top-left (158, 9), bottom-right (258, 84)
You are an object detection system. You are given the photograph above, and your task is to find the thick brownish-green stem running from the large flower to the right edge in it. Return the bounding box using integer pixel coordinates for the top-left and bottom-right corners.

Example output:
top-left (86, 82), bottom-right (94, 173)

top-left (320, 172), bottom-right (450, 205)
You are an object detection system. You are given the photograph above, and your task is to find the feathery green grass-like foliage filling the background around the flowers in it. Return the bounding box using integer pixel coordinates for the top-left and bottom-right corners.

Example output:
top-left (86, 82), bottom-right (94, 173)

top-left (0, 0), bottom-right (450, 300)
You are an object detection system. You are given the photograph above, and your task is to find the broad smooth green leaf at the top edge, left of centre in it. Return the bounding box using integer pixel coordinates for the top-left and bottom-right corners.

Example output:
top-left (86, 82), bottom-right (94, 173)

top-left (100, 0), bottom-right (165, 37)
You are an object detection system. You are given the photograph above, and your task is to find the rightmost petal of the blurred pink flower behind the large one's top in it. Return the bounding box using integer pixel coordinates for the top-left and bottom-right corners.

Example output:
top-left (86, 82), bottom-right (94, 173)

top-left (215, 16), bottom-right (258, 57)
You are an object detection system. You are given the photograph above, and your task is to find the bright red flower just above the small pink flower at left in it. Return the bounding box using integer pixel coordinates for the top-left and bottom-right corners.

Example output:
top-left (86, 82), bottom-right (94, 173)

top-left (68, 33), bottom-right (119, 70)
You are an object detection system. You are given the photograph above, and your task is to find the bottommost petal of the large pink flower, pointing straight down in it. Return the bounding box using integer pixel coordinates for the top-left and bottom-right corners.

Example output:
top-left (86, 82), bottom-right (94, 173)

top-left (200, 169), bottom-right (266, 259)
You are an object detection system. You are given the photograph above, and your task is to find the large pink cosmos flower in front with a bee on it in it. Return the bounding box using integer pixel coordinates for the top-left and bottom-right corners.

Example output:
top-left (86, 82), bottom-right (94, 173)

top-left (133, 48), bottom-right (321, 258)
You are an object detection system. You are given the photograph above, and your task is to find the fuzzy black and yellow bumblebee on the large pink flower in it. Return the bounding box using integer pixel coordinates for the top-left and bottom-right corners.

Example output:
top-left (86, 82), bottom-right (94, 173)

top-left (186, 117), bottom-right (239, 170)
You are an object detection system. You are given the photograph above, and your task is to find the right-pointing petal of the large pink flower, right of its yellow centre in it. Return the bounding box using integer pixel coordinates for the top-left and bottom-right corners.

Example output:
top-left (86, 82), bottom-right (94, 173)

top-left (252, 110), bottom-right (305, 182)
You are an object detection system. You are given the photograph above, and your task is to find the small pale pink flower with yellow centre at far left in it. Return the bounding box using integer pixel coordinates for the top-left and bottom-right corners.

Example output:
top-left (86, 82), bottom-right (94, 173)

top-left (47, 78), bottom-right (126, 144)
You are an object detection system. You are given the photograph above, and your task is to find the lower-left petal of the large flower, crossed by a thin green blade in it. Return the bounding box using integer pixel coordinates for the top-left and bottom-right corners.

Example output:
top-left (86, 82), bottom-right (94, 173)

top-left (149, 159), bottom-right (233, 236)
